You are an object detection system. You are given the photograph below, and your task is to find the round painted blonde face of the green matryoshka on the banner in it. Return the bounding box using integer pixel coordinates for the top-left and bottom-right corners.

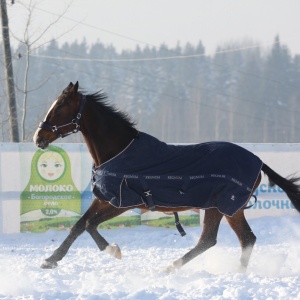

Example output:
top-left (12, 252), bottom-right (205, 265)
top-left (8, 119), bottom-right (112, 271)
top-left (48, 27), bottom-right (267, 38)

top-left (37, 151), bottom-right (65, 181)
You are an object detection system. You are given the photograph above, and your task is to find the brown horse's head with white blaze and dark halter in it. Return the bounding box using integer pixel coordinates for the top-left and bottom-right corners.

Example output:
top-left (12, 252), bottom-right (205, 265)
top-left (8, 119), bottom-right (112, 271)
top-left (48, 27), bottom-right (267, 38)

top-left (33, 82), bottom-right (85, 149)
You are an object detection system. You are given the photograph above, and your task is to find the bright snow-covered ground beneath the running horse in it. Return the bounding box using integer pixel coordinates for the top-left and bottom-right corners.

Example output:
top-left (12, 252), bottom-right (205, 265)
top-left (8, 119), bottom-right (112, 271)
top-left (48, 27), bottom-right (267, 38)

top-left (0, 216), bottom-right (300, 300)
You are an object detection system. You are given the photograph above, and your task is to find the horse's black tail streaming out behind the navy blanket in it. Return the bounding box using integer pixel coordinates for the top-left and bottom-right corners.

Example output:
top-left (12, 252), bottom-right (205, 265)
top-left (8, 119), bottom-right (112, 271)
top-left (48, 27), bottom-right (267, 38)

top-left (262, 164), bottom-right (300, 212)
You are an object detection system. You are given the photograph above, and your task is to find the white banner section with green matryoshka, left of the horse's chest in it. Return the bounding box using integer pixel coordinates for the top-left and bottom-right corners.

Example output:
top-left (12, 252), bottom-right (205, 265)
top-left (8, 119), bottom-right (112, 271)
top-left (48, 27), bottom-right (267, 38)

top-left (0, 144), bottom-right (92, 232)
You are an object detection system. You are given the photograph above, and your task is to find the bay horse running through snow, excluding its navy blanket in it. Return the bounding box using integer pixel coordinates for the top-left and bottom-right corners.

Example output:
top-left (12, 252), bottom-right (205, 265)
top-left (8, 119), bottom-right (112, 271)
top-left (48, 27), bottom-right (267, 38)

top-left (33, 81), bottom-right (300, 272)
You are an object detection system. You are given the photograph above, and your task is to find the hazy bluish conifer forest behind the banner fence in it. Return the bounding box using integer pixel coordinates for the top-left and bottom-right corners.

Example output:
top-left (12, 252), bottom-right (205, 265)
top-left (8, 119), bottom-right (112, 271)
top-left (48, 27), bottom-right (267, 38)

top-left (0, 36), bottom-right (300, 143)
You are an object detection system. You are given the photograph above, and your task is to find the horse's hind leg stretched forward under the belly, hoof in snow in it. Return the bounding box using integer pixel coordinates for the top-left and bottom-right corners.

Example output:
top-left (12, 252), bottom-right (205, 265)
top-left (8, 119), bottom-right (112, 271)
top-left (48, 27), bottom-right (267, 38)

top-left (166, 208), bottom-right (223, 272)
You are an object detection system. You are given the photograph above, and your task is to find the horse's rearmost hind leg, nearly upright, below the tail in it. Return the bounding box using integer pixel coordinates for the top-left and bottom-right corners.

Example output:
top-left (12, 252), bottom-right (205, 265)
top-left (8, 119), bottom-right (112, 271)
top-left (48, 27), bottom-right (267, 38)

top-left (226, 208), bottom-right (256, 273)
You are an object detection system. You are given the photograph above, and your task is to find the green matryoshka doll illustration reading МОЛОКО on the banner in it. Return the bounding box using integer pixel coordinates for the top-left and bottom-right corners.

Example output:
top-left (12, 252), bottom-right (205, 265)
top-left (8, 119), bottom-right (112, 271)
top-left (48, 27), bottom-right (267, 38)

top-left (20, 145), bottom-right (81, 231)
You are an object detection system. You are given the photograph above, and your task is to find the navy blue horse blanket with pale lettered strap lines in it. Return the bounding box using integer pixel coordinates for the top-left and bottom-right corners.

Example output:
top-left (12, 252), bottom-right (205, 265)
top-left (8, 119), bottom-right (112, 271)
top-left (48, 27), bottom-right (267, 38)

top-left (92, 132), bottom-right (262, 216)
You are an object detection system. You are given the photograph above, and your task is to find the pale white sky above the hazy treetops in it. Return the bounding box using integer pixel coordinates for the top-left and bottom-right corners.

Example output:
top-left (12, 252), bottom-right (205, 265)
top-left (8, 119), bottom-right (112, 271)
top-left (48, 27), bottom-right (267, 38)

top-left (7, 0), bottom-right (300, 54)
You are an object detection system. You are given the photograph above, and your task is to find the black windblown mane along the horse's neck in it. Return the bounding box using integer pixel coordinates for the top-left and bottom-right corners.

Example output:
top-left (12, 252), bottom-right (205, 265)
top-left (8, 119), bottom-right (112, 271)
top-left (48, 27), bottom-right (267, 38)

top-left (86, 91), bottom-right (136, 129)
